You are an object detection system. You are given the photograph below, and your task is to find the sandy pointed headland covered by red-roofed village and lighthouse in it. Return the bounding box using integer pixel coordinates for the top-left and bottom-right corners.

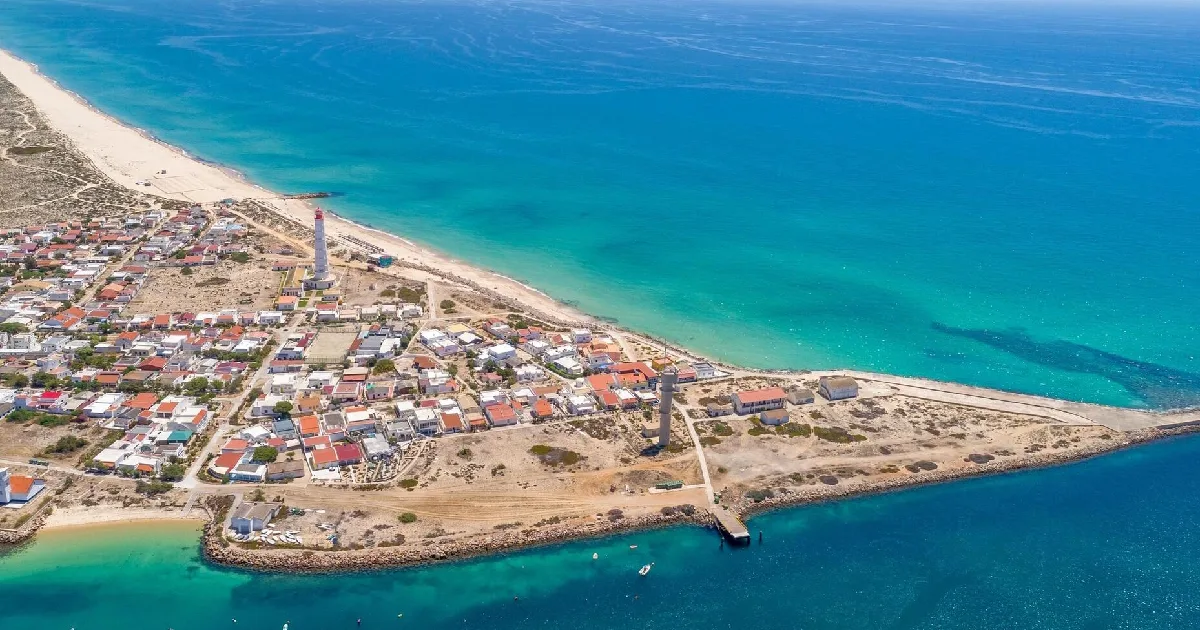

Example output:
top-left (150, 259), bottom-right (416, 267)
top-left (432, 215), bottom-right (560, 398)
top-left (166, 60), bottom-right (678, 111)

top-left (0, 67), bottom-right (1198, 570)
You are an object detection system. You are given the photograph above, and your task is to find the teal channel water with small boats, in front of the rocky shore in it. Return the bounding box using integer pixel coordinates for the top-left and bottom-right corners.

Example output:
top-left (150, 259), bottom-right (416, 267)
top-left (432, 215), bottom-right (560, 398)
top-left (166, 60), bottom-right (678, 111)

top-left (7, 438), bottom-right (1200, 630)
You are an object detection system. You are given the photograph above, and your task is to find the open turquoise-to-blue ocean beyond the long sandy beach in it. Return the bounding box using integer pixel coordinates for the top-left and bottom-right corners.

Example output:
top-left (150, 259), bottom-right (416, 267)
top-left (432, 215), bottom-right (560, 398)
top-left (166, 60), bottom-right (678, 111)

top-left (0, 0), bottom-right (1200, 408)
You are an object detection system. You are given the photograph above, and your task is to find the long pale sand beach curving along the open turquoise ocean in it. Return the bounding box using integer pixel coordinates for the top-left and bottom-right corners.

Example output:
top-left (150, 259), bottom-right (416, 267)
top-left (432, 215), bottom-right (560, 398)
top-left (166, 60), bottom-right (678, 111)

top-left (0, 45), bottom-right (590, 322)
